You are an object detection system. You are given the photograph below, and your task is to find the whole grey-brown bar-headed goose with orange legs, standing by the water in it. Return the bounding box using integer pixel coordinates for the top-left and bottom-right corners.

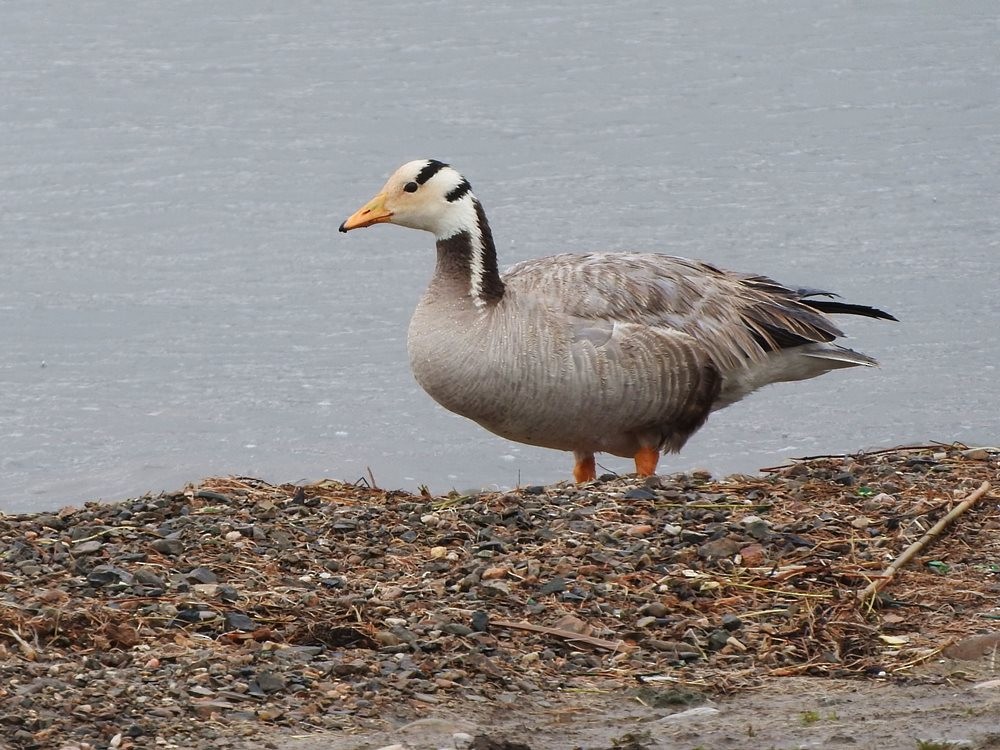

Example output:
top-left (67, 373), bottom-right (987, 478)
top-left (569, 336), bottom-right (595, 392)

top-left (340, 160), bottom-right (895, 482)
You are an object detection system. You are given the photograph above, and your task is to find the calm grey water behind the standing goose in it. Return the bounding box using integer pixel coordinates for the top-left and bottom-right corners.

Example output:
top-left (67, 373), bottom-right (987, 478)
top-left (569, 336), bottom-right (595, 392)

top-left (0, 0), bottom-right (1000, 511)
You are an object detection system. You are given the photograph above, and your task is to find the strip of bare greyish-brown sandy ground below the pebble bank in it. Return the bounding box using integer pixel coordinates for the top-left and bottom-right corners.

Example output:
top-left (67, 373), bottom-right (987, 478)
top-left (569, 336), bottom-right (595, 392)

top-left (265, 656), bottom-right (1000, 750)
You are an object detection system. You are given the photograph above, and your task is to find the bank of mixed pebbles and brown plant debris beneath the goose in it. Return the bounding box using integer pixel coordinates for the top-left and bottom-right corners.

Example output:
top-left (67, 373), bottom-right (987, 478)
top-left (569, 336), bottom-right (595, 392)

top-left (0, 445), bottom-right (1000, 750)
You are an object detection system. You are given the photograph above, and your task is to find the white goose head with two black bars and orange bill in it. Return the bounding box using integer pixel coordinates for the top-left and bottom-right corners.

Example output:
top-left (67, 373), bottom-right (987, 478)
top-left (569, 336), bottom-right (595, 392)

top-left (340, 159), bottom-right (476, 239)
